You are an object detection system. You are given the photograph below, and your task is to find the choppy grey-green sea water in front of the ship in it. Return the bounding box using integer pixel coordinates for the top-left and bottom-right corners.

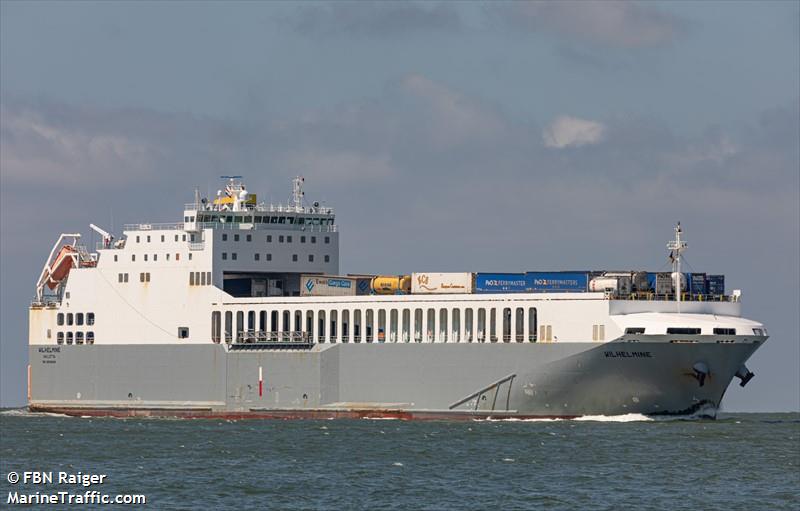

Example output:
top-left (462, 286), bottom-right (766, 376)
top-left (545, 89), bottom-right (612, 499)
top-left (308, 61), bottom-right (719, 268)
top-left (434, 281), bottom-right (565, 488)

top-left (0, 410), bottom-right (800, 510)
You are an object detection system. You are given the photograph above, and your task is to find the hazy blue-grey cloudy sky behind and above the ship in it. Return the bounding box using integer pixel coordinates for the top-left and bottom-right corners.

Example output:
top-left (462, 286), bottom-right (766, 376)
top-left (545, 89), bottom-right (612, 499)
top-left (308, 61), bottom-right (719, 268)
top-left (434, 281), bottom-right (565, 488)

top-left (0, 1), bottom-right (800, 411)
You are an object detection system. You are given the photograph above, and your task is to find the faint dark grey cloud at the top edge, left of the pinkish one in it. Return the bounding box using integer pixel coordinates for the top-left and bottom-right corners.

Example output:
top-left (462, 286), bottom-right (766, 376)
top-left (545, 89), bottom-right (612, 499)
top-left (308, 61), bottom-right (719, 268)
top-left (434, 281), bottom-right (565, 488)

top-left (282, 1), bottom-right (461, 37)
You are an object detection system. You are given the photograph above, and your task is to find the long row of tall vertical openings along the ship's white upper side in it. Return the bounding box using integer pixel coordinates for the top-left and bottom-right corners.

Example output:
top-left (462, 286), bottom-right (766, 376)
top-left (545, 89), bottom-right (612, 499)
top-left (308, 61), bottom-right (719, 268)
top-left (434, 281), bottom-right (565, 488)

top-left (211, 307), bottom-right (554, 343)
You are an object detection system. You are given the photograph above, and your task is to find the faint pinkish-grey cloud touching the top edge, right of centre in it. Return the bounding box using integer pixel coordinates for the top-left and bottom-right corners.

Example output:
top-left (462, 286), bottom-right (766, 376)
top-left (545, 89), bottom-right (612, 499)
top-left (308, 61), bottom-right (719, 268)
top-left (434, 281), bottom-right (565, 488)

top-left (490, 0), bottom-right (687, 48)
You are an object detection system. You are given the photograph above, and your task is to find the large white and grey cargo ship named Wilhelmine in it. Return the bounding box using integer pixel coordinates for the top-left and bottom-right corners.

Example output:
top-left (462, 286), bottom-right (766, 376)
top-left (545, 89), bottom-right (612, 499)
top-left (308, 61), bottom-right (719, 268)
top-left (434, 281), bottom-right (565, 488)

top-left (28, 176), bottom-right (767, 419)
